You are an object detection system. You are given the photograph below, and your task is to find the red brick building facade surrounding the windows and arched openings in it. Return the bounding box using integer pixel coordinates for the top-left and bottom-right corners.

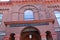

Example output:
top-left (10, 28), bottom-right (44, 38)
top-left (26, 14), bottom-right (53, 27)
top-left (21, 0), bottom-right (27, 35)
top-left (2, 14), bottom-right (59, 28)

top-left (0, 0), bottom-right (60, 40)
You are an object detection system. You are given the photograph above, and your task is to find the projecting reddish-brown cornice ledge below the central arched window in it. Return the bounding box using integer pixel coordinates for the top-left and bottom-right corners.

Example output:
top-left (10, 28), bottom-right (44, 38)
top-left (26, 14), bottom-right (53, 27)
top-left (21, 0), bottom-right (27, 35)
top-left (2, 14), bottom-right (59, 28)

top-left (4, 19), bottom-right (54, 25)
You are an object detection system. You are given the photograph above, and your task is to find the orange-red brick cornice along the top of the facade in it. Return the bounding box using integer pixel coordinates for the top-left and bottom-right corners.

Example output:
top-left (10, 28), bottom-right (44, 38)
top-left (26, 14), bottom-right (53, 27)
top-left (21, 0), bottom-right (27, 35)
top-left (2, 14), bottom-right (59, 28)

top-left (0, 0), bottom-right (60, 5)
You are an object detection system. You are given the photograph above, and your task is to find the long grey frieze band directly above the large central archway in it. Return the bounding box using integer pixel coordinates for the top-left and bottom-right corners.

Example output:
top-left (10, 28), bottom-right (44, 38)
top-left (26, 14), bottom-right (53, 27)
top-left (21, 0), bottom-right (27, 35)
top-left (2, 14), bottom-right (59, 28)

top-left (10, 22), bottom-right (49, 27)
